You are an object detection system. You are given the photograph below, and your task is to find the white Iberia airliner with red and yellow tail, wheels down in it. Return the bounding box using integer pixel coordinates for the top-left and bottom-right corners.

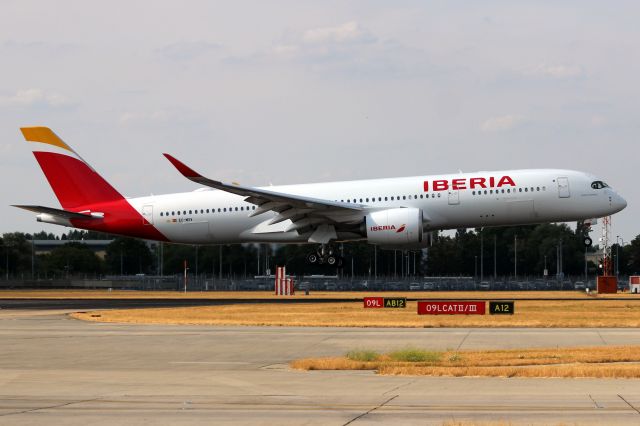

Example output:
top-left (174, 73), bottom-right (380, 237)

top-left (15, 127), bottom-right (627, 265)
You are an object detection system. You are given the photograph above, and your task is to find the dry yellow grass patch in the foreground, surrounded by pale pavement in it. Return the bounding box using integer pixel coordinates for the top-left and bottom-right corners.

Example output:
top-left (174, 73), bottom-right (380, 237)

top-left (291, 346), bottom-right (640, 378)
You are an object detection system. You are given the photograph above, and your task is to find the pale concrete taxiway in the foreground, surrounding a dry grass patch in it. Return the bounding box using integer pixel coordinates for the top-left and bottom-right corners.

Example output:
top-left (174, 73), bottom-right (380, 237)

top-left (0, 309), bottom-right (640, 425)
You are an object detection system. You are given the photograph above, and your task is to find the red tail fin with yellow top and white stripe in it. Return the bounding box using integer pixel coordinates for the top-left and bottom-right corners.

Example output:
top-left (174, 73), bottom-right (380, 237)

top-left (20, 127), bottom-right (123, 209)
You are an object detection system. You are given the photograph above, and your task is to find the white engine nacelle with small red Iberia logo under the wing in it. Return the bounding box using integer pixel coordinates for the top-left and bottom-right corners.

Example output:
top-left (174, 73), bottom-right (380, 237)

top-left (365, 208), bottom-right (423, 246)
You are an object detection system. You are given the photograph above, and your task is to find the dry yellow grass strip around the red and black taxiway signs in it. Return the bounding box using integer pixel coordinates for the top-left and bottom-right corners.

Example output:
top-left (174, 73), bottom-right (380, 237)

top-left (73, 300), bottom-right (640, 327)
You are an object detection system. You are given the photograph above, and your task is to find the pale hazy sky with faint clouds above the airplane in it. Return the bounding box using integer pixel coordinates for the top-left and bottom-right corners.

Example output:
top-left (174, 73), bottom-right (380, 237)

top-left (0, 0), bottom-right (640, 242)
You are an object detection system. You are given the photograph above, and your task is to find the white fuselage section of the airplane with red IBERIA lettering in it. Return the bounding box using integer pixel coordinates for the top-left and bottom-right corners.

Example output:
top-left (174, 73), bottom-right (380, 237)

top-left (127, 169), bottom-right (626, 244)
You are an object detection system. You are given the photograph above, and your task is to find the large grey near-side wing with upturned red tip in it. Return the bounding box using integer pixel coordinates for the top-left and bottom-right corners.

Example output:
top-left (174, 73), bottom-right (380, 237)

top-left (164, 154), bottom-right (367, 243)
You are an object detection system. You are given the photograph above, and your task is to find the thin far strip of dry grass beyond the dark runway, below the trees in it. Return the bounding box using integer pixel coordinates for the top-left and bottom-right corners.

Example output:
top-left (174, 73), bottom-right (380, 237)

top-left (5, 290), bottom-right (640, 301)
